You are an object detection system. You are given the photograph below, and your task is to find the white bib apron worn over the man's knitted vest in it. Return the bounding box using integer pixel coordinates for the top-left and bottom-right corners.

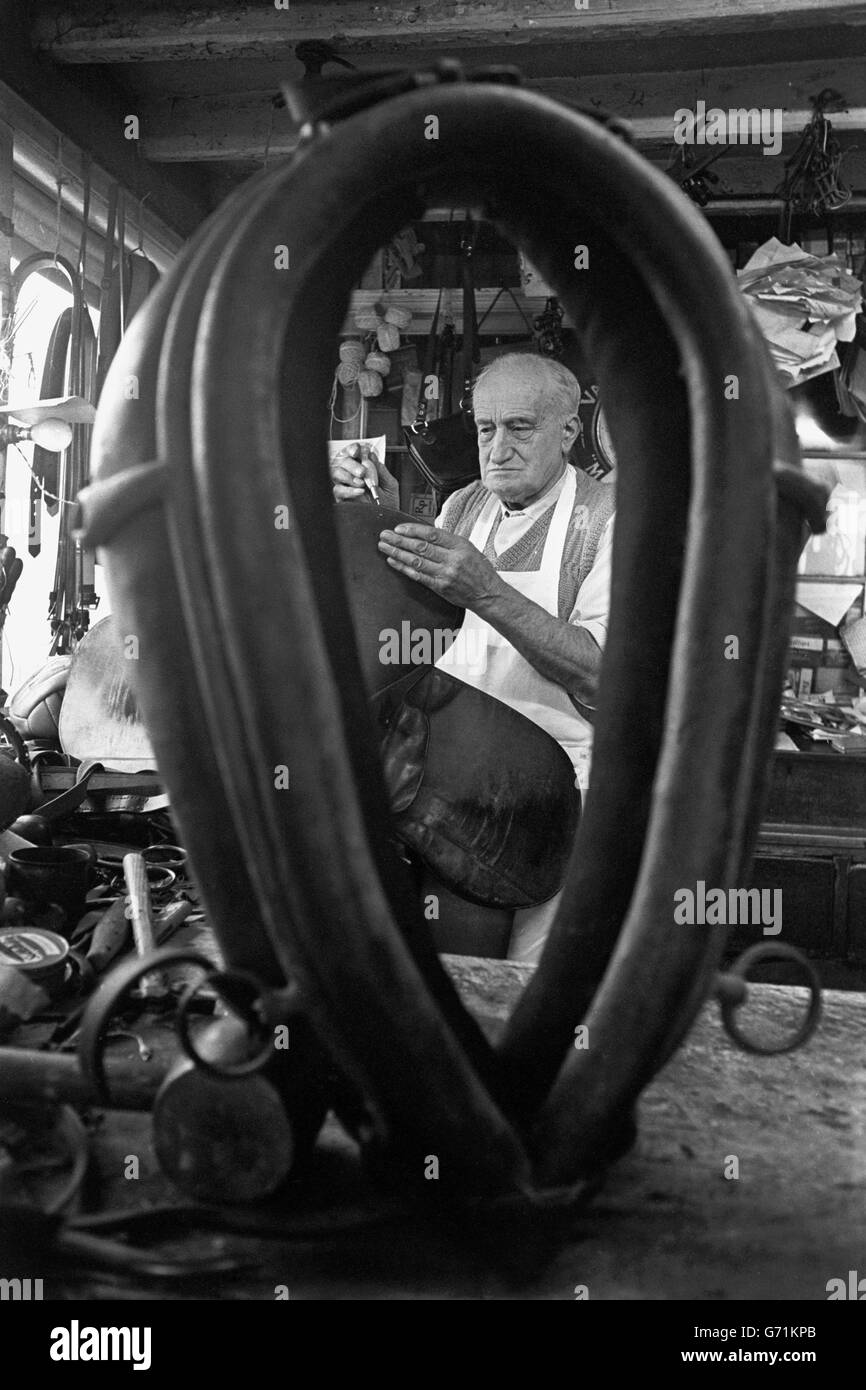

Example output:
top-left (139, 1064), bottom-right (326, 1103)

top-left (436, 467), bottom-right (592, 791)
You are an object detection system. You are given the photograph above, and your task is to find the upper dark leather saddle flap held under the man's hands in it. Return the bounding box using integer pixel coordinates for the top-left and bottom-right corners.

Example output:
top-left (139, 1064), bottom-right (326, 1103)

top-left (335, 500), bottom-right (463, 696)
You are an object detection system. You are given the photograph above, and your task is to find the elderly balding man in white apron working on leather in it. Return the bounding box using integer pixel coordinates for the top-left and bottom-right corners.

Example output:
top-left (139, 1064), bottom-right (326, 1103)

top-left (331, 353), bottom-right (613, 960)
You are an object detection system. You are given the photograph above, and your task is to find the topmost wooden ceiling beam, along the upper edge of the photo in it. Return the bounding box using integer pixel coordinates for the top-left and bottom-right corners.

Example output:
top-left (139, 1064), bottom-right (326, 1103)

top-left (32, 0), bottom-right (866, 64)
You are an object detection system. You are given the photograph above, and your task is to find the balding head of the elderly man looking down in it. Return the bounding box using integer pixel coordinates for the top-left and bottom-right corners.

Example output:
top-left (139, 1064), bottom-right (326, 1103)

top-left (474, 366), bottom-right (577, 507)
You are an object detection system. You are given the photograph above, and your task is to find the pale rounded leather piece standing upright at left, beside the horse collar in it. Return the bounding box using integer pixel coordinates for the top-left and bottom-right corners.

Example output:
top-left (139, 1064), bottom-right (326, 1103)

top-left (60, 617), bottom-right (156, 773)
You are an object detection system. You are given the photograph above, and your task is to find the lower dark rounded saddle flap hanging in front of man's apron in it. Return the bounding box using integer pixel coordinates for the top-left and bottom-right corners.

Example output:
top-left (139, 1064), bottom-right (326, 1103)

top-left (374, 669), bottom-right (581, 909)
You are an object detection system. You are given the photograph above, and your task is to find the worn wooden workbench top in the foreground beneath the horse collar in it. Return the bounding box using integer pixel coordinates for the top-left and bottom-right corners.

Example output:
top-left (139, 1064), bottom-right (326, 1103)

top-left (8, 958), bottom-right (866, 1301)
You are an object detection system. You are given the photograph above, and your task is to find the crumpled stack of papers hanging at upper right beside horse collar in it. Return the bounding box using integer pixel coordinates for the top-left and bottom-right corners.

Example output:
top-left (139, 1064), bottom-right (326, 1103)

top-left (737, 236), bottom-right (863, 386)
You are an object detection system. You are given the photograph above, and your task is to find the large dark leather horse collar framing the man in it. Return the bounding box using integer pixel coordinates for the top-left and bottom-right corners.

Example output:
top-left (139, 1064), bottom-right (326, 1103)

top-left (82, 68), bottom-right (823, 1239)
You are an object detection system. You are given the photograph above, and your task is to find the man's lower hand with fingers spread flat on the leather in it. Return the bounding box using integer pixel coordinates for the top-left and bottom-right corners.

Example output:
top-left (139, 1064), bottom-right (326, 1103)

top-left (379, 523), bottom-right (503, 609)
